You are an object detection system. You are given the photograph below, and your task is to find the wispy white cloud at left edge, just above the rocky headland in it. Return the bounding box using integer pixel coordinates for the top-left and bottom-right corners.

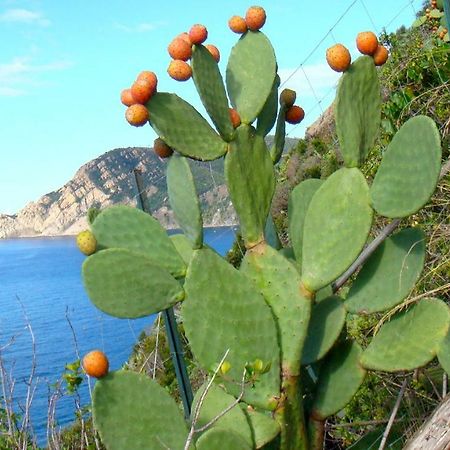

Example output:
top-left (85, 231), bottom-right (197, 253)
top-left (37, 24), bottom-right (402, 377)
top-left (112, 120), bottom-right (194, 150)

top-left (0, 57), bottom-right (72, 97)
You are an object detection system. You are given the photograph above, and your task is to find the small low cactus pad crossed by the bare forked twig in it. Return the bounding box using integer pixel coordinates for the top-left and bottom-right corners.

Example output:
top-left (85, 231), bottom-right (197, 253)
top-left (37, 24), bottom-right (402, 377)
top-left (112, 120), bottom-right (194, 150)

top-left (192, 384), bottom-right (253, 447)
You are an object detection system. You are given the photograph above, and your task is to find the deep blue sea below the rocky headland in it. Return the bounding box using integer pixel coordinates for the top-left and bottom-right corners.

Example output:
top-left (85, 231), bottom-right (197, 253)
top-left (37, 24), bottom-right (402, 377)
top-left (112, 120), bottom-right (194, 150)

top-left (0, 227), bottom-right (239, 446)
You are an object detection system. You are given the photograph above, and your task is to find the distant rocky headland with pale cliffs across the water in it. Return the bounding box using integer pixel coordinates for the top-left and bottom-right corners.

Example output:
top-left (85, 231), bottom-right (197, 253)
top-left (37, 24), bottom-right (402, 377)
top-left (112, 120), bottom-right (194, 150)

top-left (0, 148), bottom-right (236, 238)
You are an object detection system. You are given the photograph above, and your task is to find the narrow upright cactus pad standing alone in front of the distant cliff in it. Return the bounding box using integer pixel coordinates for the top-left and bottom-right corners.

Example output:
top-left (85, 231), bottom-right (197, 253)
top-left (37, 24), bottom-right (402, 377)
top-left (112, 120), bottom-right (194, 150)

top-left (167, 155), bottom-right (203, 248)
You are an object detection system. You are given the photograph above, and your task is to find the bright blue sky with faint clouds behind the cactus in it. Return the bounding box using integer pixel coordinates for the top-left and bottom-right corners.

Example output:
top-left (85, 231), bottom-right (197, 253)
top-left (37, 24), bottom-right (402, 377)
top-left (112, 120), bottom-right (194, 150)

top-left (0, 0), bottom-right (422, 214)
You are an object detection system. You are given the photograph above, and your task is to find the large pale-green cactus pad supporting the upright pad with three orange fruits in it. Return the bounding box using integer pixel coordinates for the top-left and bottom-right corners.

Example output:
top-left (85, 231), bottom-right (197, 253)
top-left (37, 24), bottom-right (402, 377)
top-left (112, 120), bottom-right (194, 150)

top-left (302, 168), bottom-right (373, 291)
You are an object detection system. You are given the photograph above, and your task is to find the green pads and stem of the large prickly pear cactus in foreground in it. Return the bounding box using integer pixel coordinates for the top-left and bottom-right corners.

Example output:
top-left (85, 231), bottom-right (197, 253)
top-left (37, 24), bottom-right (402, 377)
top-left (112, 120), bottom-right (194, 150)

top-left (76, 4), bottom-right (450, 450)
